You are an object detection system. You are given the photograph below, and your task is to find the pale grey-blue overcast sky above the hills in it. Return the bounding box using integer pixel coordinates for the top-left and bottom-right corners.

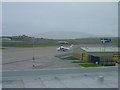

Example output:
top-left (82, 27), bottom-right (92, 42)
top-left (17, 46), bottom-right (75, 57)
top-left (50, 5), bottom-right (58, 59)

top-left (2, 2), bottom-right (118, 36)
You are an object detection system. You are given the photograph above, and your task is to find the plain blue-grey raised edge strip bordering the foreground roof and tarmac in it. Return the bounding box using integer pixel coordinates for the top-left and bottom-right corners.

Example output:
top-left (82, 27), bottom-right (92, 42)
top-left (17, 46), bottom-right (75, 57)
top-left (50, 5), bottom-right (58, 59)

top-left (2, 66), bottom-right (118, 77)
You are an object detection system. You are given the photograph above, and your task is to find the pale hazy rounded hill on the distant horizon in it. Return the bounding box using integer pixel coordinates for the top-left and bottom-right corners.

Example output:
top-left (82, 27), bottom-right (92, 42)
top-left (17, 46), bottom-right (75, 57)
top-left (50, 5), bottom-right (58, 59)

top-left (34, 31), bottom-right (109, 39)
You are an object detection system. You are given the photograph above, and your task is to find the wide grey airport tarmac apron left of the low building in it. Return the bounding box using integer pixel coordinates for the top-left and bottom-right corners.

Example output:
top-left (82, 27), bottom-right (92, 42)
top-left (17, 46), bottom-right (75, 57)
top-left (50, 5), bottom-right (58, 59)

top-left (2, 46), bottom-right (79, 70)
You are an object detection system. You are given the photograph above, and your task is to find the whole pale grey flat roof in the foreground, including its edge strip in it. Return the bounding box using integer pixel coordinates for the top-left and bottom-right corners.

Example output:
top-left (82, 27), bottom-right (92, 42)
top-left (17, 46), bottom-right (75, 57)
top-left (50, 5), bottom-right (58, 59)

top-left (2, 67), bottom-right (118, 88)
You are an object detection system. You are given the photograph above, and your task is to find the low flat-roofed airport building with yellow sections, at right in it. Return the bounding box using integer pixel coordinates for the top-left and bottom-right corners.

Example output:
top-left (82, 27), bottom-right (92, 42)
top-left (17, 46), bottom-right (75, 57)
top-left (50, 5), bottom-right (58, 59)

top-left (73, 46), bottom-right (120, 64)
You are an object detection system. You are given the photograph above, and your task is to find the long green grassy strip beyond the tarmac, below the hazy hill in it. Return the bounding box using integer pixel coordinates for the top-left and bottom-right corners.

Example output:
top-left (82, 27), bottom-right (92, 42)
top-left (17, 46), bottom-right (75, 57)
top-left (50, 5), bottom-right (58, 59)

top-left (2, 36), bottom-right (118, 47)
